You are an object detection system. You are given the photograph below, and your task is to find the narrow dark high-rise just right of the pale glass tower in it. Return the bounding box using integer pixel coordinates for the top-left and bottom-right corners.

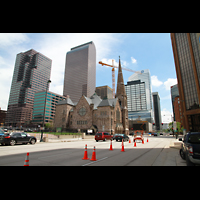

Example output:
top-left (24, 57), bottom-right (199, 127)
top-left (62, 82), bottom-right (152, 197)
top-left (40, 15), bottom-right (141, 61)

top-left (152, 92), bottom-right (162, 130)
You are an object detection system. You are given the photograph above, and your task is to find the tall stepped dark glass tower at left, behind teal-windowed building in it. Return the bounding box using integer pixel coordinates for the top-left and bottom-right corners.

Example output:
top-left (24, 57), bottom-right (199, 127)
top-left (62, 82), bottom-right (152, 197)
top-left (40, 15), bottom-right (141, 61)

top-left (6, 49), bottom-right (52, 127)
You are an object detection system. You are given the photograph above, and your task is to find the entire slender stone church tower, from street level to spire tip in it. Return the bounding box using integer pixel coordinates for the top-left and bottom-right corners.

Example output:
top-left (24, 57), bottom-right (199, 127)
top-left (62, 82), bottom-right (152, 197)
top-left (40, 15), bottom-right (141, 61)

top-left (115, 57), bottom-right (129, 135)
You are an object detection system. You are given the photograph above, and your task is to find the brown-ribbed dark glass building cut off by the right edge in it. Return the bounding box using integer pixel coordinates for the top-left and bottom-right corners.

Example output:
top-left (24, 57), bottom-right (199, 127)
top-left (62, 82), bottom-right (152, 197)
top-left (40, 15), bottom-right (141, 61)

top-left (171, 33), bottom-right (200, 131)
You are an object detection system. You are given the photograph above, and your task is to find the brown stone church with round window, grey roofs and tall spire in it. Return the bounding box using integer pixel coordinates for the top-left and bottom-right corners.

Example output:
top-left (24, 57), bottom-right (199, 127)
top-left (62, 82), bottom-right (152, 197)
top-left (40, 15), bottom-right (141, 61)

top-left (54, 59), bottom-right (129, 135)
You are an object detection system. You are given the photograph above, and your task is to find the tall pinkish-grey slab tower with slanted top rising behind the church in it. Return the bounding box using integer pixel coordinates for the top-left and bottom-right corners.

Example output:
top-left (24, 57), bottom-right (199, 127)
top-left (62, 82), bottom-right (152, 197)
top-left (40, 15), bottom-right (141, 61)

top-left (63, 42), bottom-right (96, 102)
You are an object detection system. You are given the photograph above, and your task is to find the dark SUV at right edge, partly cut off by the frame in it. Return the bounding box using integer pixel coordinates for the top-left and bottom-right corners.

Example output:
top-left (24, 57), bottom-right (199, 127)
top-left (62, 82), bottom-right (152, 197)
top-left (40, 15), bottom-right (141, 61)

top-left (180, 132), bottom-right (200, 166)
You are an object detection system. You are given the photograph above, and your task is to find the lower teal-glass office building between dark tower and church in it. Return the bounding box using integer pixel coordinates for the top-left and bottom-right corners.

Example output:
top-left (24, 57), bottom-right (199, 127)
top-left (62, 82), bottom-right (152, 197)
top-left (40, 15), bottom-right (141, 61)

top-left (32, 90), bottom-right (66, 125)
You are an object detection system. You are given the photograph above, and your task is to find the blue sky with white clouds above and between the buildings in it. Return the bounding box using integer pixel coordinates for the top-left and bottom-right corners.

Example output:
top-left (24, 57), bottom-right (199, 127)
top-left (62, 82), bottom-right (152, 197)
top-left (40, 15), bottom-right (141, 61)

top-left (0, 33), bottom-right (177, 123)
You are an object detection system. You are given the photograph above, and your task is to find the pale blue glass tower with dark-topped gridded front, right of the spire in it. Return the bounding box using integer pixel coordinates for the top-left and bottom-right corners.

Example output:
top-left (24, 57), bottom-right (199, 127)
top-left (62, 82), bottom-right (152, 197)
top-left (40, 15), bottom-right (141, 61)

top-left (125, 69), bottom-right (153, 123)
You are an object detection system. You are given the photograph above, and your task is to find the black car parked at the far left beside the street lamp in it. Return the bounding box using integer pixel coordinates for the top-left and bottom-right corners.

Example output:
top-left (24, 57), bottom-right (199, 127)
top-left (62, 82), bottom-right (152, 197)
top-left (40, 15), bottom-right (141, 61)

top-left (0, 132), bottom-right (37, 146)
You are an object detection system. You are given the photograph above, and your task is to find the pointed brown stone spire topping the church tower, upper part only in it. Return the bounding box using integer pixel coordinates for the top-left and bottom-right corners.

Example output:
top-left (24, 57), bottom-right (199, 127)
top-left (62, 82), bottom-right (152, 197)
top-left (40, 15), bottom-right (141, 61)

top-left (115, 56), bottom-right (126, 97)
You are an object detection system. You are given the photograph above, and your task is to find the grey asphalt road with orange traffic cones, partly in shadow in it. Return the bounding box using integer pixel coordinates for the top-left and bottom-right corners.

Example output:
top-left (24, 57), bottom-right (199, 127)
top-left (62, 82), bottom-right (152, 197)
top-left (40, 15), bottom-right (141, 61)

top-left (0, 136), bottom-right (186, 166)
